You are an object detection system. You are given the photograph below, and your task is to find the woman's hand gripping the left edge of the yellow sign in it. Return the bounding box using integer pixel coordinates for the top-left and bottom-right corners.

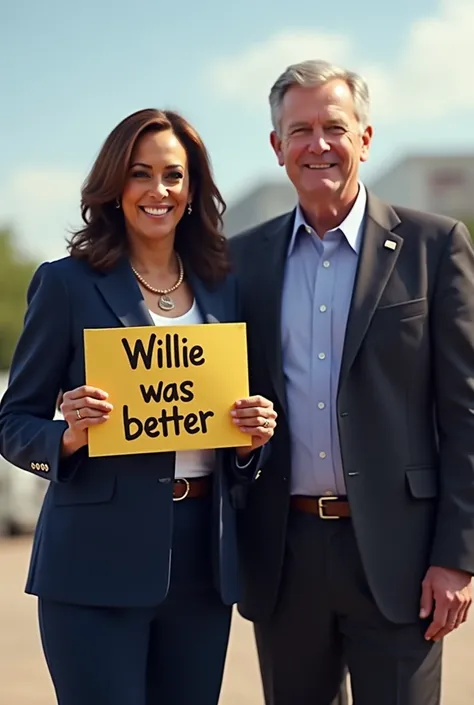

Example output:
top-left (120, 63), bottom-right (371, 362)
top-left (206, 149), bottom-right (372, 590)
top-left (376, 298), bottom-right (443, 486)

top-left (59, 385), bottom-right (113, 455)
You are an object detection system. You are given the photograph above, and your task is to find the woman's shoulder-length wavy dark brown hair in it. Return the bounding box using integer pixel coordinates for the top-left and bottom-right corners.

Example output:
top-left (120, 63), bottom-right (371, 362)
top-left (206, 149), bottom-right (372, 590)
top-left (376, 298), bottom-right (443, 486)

top-left (68, 109), bottom-right (229, 282)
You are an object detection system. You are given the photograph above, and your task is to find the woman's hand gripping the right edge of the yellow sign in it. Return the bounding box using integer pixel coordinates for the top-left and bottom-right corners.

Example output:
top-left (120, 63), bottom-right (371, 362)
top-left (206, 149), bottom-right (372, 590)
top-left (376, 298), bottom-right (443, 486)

top-left (230, 396), bottom-right (277, 460)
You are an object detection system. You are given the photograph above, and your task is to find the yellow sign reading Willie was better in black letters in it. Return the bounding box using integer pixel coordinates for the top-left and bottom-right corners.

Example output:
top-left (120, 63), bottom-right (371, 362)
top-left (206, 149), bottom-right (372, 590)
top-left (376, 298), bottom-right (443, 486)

top-left (84, 323), bottom-right (251, 457)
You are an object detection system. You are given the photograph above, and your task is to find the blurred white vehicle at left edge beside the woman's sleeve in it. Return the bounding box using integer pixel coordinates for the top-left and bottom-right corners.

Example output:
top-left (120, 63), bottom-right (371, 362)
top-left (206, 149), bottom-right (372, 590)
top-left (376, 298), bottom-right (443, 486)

top-left (0, 375), bottom-right (48, 536)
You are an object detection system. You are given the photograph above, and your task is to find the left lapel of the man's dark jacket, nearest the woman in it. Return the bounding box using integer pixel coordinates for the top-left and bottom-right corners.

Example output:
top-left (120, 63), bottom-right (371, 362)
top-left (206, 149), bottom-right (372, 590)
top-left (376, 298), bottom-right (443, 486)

top-left (254, 211), bottom-right (295, 412)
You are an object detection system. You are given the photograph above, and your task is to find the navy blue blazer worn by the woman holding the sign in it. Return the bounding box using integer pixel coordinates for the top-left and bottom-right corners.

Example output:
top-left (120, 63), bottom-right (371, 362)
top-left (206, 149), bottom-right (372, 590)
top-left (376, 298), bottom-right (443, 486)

top-left (0, 257), bottom-right (265, 607)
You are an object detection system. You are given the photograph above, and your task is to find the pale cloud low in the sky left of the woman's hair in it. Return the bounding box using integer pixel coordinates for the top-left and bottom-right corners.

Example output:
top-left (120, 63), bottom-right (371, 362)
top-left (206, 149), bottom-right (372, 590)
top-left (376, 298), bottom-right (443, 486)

top-left (0, 168), bottom-right (84, 258)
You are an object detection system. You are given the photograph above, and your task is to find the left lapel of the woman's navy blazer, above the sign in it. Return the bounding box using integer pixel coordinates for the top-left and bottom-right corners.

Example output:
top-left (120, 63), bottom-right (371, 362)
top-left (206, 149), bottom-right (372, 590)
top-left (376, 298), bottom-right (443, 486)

top-left (92, 258), bottom-right (153, 326)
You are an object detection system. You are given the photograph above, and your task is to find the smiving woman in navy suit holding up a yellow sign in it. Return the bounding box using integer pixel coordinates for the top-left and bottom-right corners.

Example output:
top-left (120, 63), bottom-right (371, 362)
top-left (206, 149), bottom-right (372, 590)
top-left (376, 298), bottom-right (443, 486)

top-left (0, 110), bottom-right (276, 705)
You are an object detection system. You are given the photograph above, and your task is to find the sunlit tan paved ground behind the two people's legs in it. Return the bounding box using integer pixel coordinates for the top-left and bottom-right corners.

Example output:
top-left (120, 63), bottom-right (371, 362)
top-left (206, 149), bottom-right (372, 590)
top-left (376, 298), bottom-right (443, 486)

top-left (0, 539), bottom-right (474, 705)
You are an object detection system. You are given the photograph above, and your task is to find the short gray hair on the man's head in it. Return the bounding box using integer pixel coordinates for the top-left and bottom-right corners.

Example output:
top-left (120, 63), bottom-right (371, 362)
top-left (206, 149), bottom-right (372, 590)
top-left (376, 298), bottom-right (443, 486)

top-left (269, 60), bottom-right (370, 133)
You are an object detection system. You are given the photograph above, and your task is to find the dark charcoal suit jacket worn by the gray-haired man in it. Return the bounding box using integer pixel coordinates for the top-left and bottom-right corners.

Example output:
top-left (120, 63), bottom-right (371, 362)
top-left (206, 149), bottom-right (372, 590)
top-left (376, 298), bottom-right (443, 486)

top-left (231, 194), bottom-right (474, 623)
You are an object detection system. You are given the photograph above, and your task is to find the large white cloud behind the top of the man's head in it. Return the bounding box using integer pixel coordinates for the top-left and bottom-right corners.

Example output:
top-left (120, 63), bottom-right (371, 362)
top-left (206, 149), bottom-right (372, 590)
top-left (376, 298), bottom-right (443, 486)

top-left (207, 0), bottom-right (474, 124)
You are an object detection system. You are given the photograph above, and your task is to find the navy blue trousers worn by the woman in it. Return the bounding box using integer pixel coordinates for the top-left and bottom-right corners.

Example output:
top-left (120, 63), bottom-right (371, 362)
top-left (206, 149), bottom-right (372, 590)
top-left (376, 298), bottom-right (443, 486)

top-left (39, 499), bottom-right (231, 705)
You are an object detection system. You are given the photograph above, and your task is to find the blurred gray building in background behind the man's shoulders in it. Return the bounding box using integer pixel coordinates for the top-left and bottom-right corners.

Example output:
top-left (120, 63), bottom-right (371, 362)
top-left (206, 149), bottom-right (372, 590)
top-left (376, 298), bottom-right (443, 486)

top-left (224, 154), bottom-right (474, 237)
